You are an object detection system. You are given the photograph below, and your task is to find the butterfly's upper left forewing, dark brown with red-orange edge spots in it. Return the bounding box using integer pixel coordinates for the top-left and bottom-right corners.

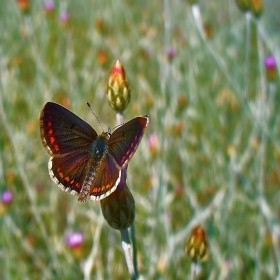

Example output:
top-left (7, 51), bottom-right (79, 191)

top-left (40, 102), bottom-right (97, 156)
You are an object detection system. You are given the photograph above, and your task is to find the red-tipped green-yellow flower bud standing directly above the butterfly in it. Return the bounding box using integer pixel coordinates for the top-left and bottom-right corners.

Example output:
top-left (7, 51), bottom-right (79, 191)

top-left (107, 60), bottom-right (130, 112)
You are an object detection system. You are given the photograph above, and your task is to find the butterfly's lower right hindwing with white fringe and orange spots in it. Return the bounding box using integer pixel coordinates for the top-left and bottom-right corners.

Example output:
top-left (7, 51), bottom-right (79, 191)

top-left (90, 153), bottom-right (122, 201)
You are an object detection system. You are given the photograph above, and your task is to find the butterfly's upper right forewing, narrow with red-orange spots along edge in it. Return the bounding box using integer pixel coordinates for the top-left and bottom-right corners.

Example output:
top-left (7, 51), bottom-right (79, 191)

top-left (108, 116), bottom-right (149, 169)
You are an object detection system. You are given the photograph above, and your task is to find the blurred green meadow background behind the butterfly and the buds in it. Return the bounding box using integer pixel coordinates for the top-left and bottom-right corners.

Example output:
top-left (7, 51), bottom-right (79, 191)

top-left (0, 0), bottom-right (280, 280)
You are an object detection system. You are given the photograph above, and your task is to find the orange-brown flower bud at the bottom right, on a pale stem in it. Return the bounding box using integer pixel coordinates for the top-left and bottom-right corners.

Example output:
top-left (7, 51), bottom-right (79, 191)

top-left (186, 226), bottom-right (209, 262)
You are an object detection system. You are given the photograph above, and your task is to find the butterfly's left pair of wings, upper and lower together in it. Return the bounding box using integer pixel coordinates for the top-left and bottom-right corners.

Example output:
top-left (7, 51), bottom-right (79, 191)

top-left (40, 102), bottom-right (97, 194)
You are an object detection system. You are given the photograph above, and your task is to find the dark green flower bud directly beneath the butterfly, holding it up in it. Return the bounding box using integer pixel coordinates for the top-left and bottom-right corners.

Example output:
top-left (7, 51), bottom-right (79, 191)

top-left (101, 168), bottom-right (135, 230)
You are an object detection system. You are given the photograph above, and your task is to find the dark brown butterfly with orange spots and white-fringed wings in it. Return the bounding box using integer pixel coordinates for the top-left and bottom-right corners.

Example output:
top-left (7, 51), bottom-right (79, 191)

top-left (40, 102), bottom-right (149, 202)
